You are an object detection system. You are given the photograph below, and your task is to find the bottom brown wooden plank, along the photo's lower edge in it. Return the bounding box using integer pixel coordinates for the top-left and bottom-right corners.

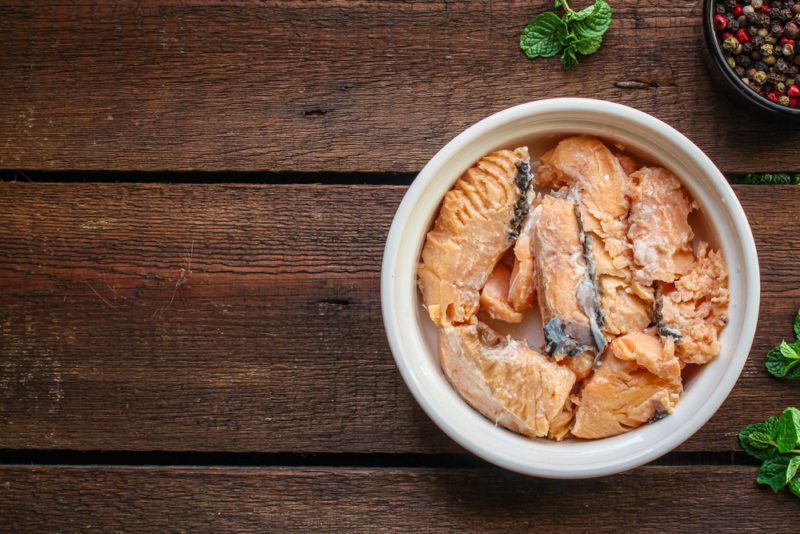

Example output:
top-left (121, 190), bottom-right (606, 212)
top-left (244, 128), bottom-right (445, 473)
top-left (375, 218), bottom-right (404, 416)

top-left (0, 466), bottom-right (800, 533)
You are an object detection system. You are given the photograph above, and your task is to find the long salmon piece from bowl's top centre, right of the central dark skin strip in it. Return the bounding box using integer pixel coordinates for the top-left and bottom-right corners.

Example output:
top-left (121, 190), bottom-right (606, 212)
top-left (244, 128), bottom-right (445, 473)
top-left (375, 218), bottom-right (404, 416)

top-left (535, 136), bottom-right (653, 337)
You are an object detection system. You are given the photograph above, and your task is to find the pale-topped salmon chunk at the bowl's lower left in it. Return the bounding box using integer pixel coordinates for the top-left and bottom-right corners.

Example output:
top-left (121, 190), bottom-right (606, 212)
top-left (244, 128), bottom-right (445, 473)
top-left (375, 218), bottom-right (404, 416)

top-left (439, 322), bottom-right (575, 437)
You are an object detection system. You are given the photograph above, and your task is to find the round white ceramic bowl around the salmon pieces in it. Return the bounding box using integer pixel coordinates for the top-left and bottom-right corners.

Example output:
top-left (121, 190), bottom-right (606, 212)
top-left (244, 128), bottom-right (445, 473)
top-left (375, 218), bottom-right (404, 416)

top-left (381, 98), bottom-right (760, 478)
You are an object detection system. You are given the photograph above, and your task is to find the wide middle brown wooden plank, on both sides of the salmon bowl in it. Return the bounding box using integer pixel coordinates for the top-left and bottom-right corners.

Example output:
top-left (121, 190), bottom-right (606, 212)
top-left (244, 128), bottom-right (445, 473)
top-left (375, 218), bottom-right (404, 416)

top-left (0, 183), bottom-right (800, 453)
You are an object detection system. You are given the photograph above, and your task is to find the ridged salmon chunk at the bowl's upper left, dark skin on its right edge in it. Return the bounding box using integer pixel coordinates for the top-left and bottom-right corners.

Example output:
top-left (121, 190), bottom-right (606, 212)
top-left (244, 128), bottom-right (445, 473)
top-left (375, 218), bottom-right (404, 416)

top-left (417, 147), bottom-right (531, 325)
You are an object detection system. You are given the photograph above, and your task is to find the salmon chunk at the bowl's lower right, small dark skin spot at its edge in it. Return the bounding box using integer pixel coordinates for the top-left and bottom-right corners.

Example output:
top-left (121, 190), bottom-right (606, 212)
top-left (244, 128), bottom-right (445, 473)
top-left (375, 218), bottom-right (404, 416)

top-left (572, 331), bottom-right (683, 439)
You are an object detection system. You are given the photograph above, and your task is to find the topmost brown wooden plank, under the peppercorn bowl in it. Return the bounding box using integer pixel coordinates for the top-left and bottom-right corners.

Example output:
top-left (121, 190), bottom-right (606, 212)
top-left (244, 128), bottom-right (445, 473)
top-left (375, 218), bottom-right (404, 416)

top-left (0, 0), bottom-right (800, 172)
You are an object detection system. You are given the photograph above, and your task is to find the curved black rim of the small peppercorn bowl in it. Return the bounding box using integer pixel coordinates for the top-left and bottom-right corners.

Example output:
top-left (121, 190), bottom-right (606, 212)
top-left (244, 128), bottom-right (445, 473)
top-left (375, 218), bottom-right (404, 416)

top-left (702, 0), bottom-right (800, 121)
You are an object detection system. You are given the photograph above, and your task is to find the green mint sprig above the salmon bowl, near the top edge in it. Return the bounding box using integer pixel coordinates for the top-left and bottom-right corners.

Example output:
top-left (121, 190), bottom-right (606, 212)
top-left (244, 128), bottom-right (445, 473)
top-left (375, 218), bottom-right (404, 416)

top-left (519, 0), bottom-right (611, 70)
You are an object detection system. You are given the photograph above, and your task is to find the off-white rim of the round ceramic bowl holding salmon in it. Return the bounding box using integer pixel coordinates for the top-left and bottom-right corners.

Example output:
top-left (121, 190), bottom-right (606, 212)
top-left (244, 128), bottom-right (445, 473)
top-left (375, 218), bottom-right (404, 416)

top-left (381, 98), bottom-right (760, 479)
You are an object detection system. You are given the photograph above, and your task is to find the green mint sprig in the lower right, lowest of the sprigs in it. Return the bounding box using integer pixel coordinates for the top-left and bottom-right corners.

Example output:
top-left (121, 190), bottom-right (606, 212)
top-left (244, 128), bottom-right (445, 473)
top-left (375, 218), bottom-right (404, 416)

top-left (739, 407), bottom-right (800, 497)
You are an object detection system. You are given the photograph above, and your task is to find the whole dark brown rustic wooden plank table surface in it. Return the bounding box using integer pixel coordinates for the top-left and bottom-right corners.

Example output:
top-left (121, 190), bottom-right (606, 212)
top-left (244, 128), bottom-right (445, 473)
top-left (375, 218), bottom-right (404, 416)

top-left (0, 0), bottom-right (800, 532)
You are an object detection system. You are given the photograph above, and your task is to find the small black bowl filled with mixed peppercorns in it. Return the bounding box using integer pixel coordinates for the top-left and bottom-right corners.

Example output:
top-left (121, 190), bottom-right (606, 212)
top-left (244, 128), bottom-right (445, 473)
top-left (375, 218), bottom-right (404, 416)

top-left (703, 0), bottom-right (800, 120)
